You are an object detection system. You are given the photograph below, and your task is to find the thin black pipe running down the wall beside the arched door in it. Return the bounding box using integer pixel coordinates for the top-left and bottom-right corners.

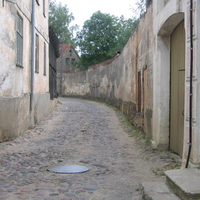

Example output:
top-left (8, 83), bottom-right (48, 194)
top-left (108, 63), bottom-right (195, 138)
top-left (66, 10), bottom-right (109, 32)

top-left (185, 0), bottom-right (193, 168)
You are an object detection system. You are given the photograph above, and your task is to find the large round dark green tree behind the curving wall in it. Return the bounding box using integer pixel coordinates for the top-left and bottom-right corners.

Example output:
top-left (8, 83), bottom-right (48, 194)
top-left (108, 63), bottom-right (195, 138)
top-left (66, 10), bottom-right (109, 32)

top-left (77, 11), bottom-right (137, 68)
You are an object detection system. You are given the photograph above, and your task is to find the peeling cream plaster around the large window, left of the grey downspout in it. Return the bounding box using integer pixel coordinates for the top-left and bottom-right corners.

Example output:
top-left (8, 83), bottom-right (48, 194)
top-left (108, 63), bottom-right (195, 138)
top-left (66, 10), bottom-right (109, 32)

top-left (0, 2), bottom-right (30, 97)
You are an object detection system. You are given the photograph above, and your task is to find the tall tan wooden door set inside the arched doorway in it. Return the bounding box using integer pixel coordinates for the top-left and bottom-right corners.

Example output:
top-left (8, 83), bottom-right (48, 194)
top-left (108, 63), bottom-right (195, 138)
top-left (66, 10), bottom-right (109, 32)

top-left (170, 21), bottom-right (185, 156)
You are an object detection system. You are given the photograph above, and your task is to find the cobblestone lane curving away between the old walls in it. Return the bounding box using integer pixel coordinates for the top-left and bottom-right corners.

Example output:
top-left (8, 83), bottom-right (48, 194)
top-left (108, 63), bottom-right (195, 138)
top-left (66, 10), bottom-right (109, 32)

top-left (0, 98), bottom-right (179, 200)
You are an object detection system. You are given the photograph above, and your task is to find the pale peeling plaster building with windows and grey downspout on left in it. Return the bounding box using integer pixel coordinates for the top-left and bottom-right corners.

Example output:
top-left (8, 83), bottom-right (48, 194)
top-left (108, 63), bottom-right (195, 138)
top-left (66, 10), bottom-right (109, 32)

top-left (0, 0), bottom-right (56, 141)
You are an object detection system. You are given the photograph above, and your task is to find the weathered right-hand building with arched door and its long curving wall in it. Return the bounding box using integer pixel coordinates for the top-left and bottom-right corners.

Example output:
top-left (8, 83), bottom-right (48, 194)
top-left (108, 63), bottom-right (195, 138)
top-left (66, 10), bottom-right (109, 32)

top-left (63, 0), bottom-right (200, 166)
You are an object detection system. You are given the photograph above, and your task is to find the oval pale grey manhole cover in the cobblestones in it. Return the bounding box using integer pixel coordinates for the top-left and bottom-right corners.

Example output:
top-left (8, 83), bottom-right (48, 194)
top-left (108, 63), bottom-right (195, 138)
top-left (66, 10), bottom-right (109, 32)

top-left (48, 165), bottom-right (89, 174)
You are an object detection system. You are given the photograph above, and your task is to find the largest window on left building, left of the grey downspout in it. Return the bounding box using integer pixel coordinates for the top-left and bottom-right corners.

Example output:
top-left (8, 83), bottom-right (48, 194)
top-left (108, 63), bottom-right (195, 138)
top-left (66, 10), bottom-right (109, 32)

top-left (16, 15), bottom-right (23, 67)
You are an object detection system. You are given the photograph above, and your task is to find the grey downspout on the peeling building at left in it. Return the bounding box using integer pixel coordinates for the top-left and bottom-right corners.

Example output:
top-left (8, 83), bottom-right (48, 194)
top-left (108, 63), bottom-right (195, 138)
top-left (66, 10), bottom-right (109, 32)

top-left (30, 0), bottom-right (35, 111)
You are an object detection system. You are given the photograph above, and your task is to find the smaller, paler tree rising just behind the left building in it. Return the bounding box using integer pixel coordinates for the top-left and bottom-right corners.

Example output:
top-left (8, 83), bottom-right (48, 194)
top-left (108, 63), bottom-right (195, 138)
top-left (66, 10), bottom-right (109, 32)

top-left (49, 0), bottom-right (77, 43)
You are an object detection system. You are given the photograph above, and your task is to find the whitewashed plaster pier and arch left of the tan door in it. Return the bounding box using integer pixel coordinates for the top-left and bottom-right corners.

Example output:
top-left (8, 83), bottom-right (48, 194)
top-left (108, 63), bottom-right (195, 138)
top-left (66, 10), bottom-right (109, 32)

top-left (153, 0), bottom-right (185, 149)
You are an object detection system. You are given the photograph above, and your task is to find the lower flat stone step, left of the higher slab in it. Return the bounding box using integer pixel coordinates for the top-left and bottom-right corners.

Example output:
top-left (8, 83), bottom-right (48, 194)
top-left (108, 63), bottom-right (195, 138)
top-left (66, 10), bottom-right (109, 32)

top-left (141, 182), bottom-right (180, 200)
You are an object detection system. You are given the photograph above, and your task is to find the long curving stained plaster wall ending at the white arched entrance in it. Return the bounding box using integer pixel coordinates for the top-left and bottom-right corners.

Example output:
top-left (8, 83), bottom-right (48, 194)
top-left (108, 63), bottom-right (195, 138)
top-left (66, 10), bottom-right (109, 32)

top-left (62, 7), bottom-right (153, 137)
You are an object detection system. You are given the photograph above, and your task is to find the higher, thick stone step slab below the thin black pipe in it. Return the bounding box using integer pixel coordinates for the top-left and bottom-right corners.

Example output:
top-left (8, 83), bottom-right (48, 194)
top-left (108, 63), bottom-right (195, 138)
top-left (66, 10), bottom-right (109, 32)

top-left (165, 169), bottom-right (200, 200)
